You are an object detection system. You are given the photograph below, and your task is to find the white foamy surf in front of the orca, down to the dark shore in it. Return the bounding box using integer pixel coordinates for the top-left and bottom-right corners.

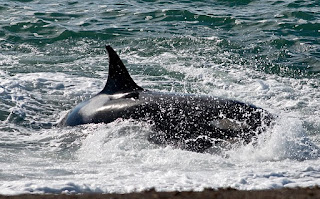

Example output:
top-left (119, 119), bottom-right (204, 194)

top-left (0, 116), bottom-right (320, 194)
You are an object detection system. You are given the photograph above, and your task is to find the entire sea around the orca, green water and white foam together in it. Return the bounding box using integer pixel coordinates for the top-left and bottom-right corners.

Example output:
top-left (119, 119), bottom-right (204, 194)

top-left (0, 0), bottom-right (320, 195)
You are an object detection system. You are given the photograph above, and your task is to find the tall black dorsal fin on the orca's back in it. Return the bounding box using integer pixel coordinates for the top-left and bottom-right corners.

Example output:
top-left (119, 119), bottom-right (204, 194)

top-left (101, 45), bottom-right (143, 95)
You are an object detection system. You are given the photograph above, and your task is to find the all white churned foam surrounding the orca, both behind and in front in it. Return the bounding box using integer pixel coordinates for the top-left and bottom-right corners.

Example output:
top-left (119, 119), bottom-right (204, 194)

top-left (0, 40), bottom-right (320, 194)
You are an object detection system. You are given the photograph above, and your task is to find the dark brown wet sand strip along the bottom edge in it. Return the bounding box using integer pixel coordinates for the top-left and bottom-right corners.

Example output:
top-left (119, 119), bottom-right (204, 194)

top-left (0, 187), bottom-right (320, 199)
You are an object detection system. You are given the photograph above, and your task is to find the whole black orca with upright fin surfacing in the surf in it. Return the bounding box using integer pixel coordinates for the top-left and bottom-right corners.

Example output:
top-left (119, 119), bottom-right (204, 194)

top-left (60, 45), bottom-right (274, 152)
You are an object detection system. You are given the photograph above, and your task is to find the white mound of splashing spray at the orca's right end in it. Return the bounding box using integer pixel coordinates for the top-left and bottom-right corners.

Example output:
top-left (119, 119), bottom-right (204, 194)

top-left (227, 113), bottom-right (320, 162)
